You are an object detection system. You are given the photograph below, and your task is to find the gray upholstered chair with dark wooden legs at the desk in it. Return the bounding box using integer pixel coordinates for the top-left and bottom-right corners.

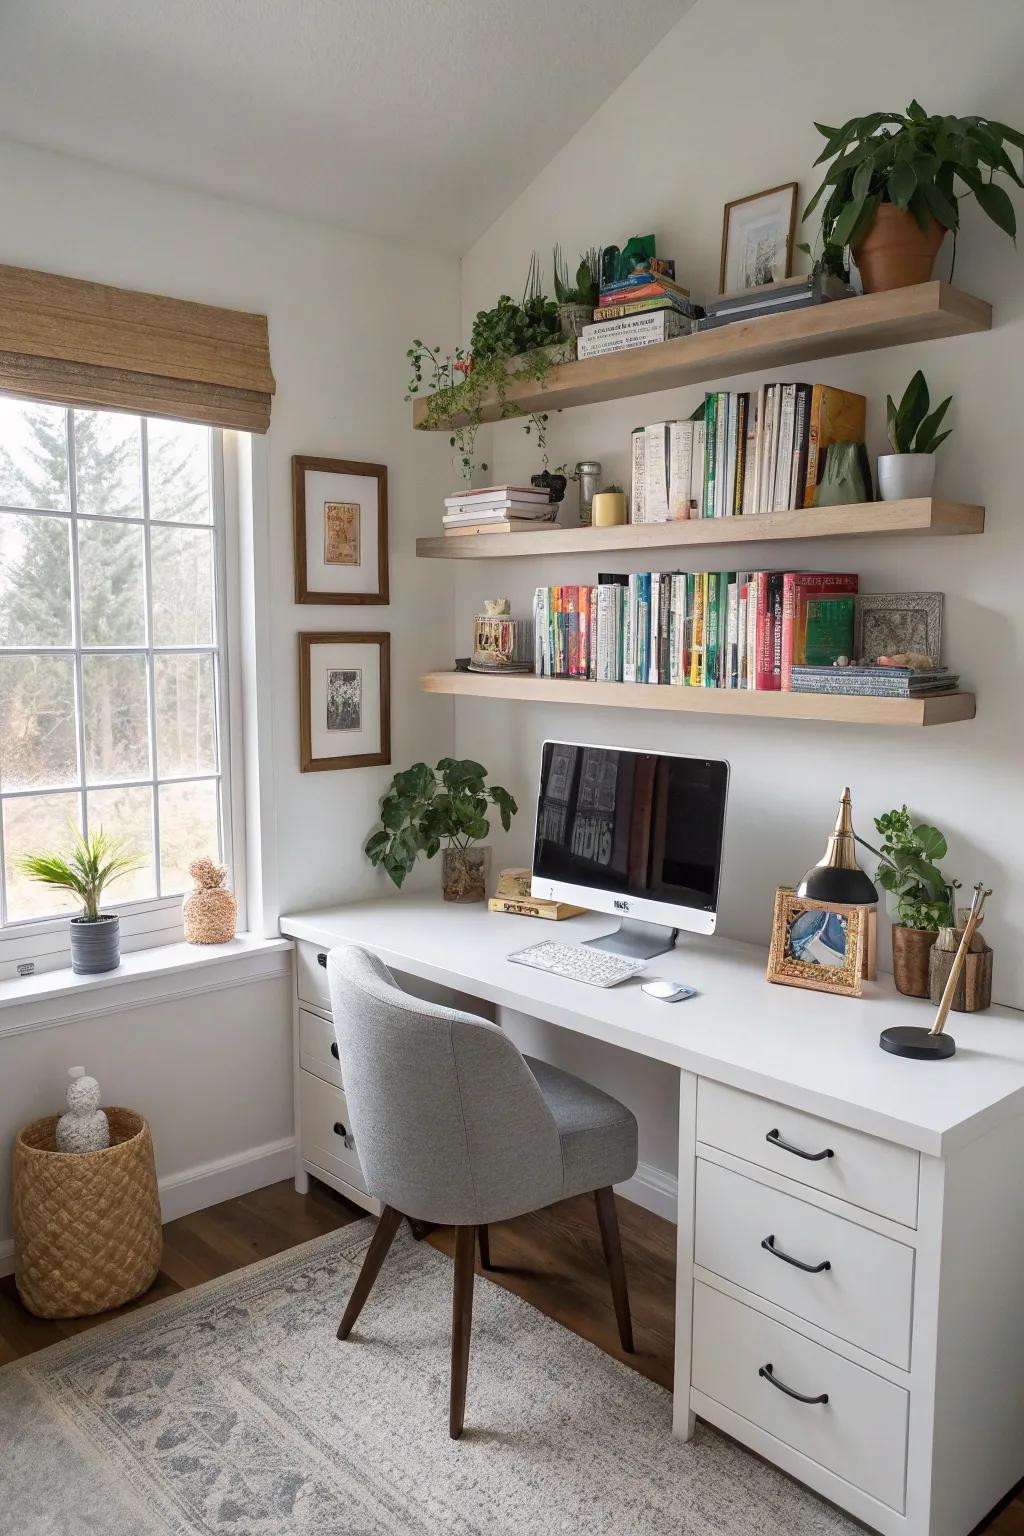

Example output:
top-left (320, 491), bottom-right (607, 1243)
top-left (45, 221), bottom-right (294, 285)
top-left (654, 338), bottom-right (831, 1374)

top-left (327, 945), bottom-right (637, 1439)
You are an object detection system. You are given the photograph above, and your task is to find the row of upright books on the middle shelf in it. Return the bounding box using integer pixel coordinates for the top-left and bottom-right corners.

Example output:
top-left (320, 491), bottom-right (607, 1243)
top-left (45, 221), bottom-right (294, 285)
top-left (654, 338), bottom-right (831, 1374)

top-left (629, 384), bottom-right (867, 522)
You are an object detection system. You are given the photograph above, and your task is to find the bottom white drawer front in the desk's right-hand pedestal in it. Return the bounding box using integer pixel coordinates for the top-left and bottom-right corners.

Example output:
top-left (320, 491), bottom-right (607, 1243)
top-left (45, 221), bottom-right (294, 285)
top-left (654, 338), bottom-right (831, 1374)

top-left (692, 1283), bottom-right (909, 1511)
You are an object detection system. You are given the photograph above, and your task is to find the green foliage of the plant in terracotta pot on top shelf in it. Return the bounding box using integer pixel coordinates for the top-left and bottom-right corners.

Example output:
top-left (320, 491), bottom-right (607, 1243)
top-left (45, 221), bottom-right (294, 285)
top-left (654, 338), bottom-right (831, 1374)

top-left (803, 101), bottom-right (1024, 272)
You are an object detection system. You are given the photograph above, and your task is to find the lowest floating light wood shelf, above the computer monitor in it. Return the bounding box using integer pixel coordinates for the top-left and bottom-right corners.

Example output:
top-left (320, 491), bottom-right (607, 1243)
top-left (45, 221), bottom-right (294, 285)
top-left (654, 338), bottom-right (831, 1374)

top-left (419, 671), bottom-right (975, 725)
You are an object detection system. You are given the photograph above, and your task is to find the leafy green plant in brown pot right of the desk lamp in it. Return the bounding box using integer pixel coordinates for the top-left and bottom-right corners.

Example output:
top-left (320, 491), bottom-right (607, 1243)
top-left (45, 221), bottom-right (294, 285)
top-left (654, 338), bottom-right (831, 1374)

top-left (872, 805), bottom-right (960, 997)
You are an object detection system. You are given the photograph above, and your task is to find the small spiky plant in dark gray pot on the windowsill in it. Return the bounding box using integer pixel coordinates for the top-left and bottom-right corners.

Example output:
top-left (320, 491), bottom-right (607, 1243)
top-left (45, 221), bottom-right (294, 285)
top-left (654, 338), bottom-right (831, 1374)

top-left (18, 828), bottom-right (143, 975)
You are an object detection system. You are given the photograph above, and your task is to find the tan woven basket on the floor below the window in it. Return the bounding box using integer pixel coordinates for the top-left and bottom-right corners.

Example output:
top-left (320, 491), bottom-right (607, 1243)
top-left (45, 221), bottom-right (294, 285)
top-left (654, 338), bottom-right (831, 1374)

top-left (14, 1109), bottom-right (163, 1318)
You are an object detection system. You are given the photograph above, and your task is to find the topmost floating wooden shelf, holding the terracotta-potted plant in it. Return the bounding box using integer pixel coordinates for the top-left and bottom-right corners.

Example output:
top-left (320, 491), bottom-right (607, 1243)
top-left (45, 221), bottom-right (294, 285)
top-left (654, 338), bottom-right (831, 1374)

top-left (413, 283), bottom-right (992, 430)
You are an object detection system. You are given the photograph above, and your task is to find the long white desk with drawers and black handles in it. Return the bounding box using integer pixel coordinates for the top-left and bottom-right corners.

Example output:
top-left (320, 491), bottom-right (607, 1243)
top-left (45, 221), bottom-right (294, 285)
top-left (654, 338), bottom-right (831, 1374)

top-left (281, 897), bottom-right (1024, 1536)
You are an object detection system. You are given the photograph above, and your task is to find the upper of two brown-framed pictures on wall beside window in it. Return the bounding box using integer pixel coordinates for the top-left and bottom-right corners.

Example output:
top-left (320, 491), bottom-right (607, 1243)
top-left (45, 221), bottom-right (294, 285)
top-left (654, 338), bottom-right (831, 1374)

top-left (292, 453), bottom-right (388, 604)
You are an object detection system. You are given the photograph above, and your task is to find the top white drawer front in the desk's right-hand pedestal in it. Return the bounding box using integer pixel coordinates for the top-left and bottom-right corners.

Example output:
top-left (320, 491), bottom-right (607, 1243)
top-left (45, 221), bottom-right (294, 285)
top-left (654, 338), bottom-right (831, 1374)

top-left (697, 1078), bottom-right (920, 1227)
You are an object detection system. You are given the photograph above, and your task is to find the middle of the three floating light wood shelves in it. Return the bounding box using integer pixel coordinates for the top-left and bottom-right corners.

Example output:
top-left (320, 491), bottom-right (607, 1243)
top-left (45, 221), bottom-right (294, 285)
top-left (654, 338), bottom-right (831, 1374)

top-left (416, 496), bottom-right (986, 561)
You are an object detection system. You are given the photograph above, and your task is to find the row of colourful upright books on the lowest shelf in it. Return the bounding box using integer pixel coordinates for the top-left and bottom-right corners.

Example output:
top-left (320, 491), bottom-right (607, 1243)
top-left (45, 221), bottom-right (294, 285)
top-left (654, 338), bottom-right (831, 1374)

top-left (533, 571), bottom-right (857, 691)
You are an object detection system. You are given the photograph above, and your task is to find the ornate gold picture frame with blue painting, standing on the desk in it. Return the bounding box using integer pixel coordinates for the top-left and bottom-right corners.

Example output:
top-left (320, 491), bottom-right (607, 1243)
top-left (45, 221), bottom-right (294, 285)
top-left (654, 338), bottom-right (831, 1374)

top-left (768, 885), bottom-right (867, 997)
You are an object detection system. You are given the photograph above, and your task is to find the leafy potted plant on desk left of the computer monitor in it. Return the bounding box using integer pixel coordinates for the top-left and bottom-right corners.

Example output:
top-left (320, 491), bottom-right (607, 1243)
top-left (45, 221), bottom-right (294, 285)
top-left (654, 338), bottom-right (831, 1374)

top-left (364, 757), bottom-right (519, 902)
